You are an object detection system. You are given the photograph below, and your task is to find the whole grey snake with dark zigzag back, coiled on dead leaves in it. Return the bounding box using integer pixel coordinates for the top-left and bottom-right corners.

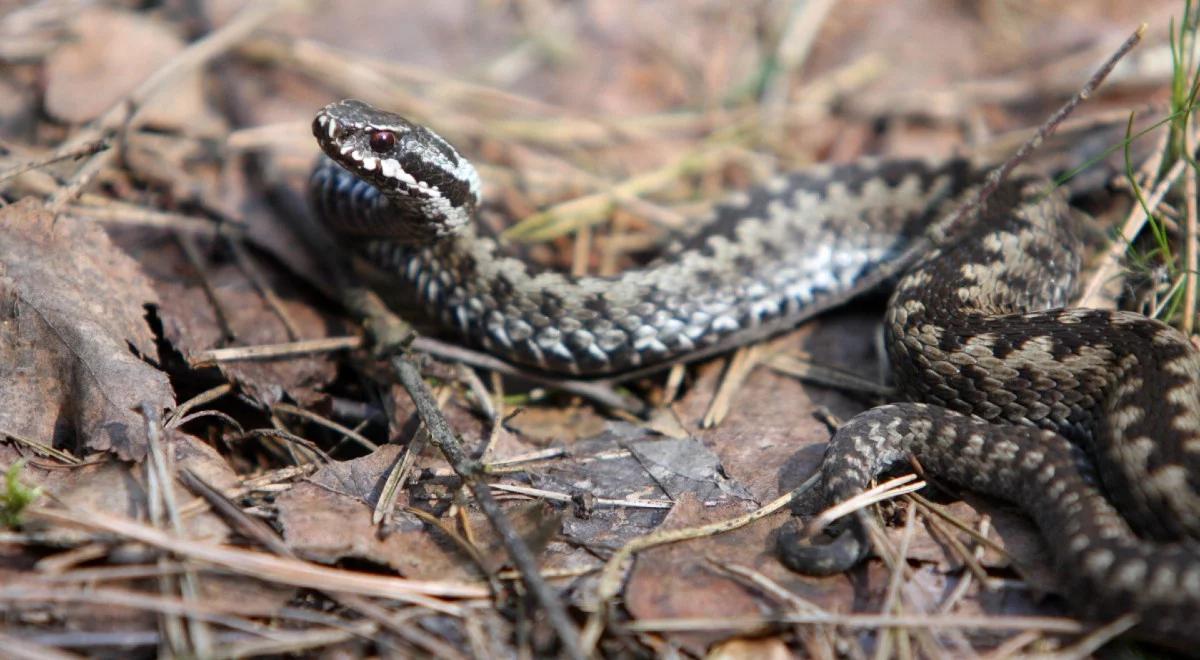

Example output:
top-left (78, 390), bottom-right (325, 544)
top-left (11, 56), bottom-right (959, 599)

top-left (308, 100), bottom-right (1200, 650)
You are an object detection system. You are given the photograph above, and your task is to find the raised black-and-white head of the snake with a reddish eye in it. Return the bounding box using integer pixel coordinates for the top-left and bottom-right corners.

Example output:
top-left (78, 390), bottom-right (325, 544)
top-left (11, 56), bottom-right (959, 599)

top-left (312, 100), bottom-right (480, 216)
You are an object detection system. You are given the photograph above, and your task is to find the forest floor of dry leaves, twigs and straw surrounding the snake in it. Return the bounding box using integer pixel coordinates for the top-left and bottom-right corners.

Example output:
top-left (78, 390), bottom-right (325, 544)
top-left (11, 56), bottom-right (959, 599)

top-left (0, 0), bottom-right (1180, 658)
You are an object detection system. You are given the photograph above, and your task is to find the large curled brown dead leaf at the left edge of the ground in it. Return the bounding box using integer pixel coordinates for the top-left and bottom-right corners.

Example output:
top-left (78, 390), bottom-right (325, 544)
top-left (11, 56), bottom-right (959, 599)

top-left (0, 200), bottom-right (175, 461)
